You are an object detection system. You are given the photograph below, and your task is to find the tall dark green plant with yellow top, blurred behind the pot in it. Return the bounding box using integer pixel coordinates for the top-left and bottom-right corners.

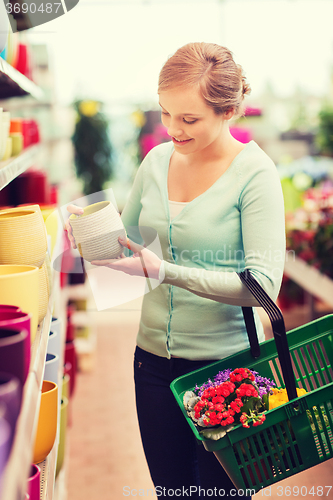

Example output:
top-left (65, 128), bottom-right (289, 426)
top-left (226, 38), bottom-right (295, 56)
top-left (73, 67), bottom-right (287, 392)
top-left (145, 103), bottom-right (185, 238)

top-left (72, 100), bottom-right (113, 195)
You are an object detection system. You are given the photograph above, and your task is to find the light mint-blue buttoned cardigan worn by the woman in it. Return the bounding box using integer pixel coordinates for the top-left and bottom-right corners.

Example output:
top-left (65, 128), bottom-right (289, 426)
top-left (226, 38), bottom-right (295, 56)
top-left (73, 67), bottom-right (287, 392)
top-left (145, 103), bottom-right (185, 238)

top-left (122, 141), bottom-right (285, 360)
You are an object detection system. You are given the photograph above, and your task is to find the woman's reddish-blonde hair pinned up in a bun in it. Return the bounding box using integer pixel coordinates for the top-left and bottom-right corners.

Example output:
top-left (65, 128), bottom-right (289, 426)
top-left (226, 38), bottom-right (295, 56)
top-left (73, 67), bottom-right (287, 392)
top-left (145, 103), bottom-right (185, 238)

top-left (158, 42), bottom-right (251, 115)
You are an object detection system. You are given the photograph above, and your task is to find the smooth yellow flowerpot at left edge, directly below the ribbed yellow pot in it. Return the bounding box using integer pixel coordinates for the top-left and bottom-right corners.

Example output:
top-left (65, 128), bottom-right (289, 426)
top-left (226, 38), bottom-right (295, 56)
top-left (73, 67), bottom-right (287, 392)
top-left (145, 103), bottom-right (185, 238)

top-left (0, 265), bottom-right (39, 343)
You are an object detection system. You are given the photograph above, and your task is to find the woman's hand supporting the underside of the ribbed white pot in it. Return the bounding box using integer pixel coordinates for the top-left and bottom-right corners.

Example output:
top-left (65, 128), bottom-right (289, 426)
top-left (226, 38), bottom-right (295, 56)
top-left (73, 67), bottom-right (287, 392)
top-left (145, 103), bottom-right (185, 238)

top-left (91, 236), bottom-right (162, 279)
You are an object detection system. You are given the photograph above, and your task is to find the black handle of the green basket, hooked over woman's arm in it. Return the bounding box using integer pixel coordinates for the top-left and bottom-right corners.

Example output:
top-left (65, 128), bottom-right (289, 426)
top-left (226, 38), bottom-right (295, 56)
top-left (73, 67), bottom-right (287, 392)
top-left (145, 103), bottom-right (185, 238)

top-left (238, 271), bottom-right (297, 400)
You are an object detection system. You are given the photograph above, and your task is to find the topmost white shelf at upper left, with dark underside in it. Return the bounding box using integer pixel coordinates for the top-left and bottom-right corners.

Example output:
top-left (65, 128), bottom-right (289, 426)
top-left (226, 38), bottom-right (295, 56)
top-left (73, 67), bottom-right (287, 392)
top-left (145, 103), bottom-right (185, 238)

top-left (0, 58), bottom-right (44, 100)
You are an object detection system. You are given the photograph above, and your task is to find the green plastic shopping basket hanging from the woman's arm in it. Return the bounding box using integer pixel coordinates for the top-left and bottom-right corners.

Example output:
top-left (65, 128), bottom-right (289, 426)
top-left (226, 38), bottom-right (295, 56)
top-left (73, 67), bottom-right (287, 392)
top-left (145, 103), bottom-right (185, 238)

top-left (170, 272), bottom-right (333, 491)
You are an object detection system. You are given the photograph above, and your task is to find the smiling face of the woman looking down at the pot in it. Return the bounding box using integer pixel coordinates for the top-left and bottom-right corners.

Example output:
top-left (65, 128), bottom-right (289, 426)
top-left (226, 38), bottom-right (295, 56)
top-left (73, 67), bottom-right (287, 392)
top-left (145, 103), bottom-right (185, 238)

top-left (159, 87), bottom-right (226, 155)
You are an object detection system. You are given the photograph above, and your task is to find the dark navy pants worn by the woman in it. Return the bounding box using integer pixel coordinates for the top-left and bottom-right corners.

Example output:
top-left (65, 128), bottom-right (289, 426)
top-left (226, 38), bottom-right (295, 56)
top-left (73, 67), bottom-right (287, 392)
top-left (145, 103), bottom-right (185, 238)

top-left (134, 347), bottom-right (251, 500)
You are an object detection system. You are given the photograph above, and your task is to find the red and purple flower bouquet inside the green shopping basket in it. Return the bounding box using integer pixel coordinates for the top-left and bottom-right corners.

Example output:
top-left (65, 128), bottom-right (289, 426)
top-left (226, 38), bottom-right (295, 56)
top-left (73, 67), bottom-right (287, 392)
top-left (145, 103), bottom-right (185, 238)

top-left (183, 368), bottom-right (275, 440)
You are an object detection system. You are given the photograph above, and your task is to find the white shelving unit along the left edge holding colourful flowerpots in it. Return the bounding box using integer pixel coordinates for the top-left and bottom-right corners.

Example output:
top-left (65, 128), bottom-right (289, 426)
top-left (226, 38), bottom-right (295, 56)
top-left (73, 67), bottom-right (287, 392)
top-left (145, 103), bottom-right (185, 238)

top-left (0, 54), bottom-right (68, 500)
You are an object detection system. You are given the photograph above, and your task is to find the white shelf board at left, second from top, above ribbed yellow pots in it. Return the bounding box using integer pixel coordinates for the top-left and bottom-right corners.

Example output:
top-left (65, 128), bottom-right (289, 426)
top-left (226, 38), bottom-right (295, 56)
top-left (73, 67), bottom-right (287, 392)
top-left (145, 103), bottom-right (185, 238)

top-left (0, 144), bottom-right (41, 190)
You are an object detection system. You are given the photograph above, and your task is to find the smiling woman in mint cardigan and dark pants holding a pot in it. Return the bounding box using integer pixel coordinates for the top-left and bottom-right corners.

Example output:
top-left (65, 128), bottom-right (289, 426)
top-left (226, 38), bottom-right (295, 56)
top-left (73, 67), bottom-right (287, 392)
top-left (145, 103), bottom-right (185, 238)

top-left (69, 43), bottom-right (285, 499)
